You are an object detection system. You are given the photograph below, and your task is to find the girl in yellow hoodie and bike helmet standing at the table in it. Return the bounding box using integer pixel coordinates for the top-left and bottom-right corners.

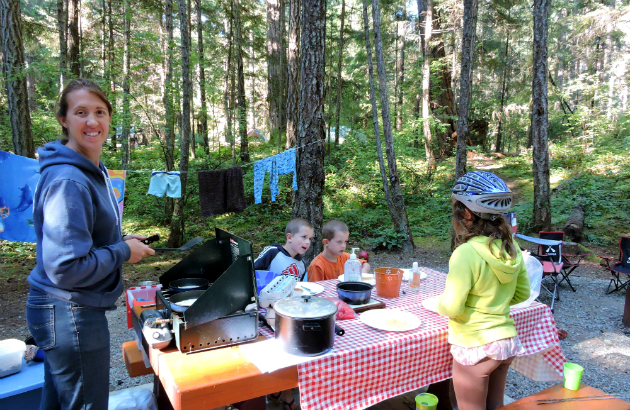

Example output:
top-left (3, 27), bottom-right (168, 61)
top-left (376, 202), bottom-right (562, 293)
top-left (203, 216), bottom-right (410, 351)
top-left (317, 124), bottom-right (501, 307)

top-left (438, 171), bottom-right (529, 410)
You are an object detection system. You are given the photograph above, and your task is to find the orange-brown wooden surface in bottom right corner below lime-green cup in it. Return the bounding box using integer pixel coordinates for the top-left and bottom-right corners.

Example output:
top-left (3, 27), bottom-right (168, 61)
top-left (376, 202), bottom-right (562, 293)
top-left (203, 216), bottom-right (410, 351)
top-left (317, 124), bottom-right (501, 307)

top-left (500, 383), bottom-right (630, 410)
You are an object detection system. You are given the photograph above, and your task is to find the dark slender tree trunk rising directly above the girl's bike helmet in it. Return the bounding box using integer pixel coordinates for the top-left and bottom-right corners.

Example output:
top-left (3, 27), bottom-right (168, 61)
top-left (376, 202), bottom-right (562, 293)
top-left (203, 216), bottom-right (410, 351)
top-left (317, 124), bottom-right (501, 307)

top-left (455, 0), bottom-right (478, 179)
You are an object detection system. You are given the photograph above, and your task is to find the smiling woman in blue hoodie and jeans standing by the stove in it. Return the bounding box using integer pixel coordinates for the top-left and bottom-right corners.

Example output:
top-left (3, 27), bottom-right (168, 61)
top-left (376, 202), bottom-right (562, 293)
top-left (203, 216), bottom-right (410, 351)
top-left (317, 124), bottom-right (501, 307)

top-left (26, 79), bottom-right (155, 410)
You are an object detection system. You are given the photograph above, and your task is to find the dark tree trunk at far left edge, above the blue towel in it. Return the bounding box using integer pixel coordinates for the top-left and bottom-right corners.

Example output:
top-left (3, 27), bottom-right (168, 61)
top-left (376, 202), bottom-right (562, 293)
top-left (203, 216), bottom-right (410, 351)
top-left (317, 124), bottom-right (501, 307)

top-left (0, 0), bottom-right (35, 158)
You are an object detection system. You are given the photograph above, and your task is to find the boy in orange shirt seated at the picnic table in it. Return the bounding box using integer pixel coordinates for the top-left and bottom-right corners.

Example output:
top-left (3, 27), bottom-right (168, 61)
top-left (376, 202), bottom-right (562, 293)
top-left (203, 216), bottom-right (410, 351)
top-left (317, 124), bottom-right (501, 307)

top-left (307, 220), bottom-right (370, 282)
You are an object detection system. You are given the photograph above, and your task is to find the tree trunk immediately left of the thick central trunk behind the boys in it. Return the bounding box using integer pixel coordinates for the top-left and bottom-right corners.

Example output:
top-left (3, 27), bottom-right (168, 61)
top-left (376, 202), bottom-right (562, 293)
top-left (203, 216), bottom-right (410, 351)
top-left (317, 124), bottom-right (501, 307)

top-left (286, 0), bottom-right (302, 149)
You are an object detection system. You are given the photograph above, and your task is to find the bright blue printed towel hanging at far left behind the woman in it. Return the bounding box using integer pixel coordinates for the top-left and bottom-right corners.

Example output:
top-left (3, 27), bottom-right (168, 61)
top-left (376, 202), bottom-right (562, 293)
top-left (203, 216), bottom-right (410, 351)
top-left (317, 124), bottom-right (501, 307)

top-left (0, 151), bottom-right (39, 242)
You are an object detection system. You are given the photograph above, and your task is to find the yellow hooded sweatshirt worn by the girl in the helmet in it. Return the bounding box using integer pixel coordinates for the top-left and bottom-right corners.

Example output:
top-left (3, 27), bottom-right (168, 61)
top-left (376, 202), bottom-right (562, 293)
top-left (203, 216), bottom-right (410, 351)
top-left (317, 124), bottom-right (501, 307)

top-left (438, 236), bottom-right (529, 348)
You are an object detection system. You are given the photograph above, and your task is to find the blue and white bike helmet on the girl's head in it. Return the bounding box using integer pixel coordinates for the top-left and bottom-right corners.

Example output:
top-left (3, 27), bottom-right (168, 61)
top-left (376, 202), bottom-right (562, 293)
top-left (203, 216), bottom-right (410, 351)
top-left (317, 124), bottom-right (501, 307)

top-left (452, 171), bottom-right (512, 221)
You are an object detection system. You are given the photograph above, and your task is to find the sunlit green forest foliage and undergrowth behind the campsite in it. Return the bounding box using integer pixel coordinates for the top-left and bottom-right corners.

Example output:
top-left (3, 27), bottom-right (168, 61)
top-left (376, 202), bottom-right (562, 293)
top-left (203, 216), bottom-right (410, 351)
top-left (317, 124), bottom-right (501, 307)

top-left (0, 0), bottom-right (630, 258)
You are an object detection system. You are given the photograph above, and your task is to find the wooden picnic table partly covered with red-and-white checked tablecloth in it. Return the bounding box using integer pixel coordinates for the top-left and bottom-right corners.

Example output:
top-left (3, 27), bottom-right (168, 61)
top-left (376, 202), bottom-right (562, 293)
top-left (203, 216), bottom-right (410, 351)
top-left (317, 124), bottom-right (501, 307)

top-left (123, 268), bottom-right (566, 410)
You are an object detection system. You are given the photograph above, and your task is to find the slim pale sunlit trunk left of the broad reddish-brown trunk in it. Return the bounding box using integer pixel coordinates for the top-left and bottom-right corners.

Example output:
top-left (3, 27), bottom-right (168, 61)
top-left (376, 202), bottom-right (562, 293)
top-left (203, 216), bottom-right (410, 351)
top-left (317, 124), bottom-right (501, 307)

top-left (422, 0), bottom-right (435, 171)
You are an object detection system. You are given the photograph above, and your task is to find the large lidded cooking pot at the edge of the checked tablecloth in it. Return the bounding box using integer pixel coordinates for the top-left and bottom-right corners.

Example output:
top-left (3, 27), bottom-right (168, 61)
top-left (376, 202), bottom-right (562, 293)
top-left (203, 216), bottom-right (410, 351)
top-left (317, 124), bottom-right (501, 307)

top-left (274, 296), bottom-right (343, 356)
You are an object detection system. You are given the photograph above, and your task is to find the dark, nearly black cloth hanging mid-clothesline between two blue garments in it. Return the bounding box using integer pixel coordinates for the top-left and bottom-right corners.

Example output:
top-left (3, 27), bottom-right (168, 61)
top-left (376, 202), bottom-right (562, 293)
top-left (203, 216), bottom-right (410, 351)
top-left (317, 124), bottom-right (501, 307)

top-left (197, 167), bottom-right (247, 218)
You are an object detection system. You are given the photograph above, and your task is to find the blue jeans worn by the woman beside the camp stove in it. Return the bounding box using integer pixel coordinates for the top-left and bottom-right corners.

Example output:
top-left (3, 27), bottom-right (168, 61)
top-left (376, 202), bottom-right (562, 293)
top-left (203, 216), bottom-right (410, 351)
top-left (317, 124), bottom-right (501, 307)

top-left (26, 287), bottom-right (109, 410)
